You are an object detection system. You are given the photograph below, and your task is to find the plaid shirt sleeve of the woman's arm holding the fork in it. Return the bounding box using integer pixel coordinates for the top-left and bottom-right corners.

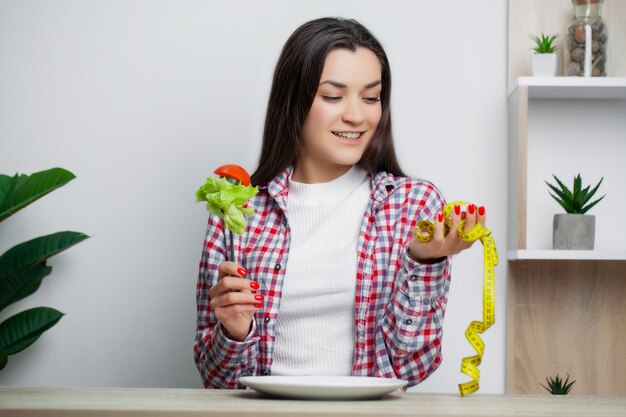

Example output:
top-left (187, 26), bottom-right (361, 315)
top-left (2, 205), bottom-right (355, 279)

top-left (193, 215), bottom-right (259, 388)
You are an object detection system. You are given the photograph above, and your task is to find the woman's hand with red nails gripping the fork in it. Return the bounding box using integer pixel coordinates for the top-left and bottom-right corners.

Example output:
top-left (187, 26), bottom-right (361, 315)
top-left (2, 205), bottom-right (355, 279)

top-left (209, 261), bottom-right (263, 342)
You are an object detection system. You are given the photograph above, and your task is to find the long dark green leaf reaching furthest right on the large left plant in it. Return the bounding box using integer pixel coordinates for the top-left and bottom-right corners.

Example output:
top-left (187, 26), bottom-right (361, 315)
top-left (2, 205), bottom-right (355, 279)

top-left (0, 231), bottom-right (89, 277)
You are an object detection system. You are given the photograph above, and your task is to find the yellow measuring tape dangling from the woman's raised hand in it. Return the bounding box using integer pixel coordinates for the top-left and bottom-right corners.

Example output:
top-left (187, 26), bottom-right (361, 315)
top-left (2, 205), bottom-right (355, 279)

top-left (415, 201), bottom-right (498, 397)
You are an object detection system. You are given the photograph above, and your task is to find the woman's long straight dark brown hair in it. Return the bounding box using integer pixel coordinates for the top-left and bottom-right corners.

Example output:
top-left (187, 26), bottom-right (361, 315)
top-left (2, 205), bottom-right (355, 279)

top-left (252, 17), bottom-right (404, 185)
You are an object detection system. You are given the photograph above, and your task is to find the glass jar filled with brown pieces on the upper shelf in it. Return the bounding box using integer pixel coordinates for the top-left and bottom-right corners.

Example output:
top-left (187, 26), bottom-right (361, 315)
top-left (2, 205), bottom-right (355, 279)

top-left (565, 0), bottom-right (609, 77)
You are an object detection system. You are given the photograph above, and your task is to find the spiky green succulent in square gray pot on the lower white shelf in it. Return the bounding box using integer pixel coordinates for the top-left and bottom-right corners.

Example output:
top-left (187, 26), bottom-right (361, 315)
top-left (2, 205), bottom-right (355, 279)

top-left (546, 174), bottom-right (606, 250)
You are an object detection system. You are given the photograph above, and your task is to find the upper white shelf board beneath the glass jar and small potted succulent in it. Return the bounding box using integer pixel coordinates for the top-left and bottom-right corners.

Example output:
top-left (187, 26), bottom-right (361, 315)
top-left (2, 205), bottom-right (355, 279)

top-left (509, 77), bottom-right (626, 100)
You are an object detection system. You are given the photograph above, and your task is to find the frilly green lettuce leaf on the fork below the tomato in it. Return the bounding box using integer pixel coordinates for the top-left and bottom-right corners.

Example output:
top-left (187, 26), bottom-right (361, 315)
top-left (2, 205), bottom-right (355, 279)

top-left (196, 177), bottom-right (259, 234)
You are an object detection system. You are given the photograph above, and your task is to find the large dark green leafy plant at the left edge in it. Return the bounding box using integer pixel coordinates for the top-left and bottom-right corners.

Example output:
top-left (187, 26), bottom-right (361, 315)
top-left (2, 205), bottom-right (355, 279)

top-left (0, 168), bottom-right (88, 369)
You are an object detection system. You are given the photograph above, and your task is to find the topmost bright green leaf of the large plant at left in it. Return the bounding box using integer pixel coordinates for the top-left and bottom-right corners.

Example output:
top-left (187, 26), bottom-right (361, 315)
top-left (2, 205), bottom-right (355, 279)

top-left (0, 168), bottom-right (76, 221)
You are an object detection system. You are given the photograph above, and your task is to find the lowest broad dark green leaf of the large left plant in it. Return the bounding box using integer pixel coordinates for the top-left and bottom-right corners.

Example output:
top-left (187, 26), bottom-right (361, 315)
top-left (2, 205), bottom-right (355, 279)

top-left (0, 307), bottom-right (63, 355)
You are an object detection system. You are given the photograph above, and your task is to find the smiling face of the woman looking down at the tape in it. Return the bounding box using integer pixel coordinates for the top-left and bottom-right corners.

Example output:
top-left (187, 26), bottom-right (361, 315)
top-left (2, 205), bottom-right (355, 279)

top-left (292, 47), bottom-right (382, 183)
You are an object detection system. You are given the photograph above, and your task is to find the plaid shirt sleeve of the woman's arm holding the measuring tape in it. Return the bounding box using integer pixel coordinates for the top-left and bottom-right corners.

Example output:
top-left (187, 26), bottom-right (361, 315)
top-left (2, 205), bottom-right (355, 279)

top-left (377, 182), bottom-right (450, 387)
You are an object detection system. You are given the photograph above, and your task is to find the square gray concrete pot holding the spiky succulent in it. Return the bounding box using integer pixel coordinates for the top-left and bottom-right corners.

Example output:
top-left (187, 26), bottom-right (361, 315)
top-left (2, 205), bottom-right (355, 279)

top-left (552, 214), bottom-right (596, 250)
